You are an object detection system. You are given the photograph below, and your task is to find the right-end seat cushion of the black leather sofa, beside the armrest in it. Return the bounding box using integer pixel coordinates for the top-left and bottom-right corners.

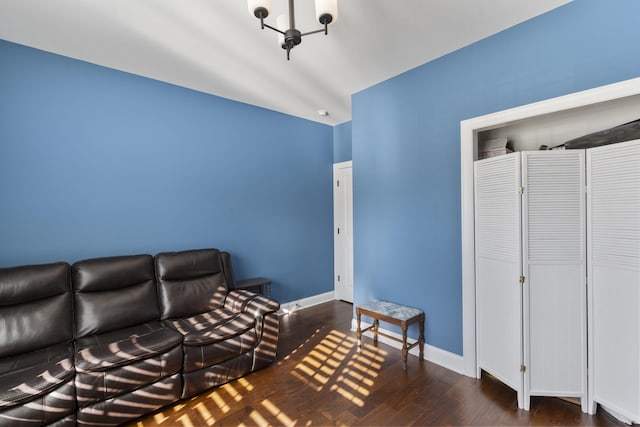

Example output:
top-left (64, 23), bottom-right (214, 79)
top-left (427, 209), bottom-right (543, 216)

top-left (167, 308), bottom-right (257, 372)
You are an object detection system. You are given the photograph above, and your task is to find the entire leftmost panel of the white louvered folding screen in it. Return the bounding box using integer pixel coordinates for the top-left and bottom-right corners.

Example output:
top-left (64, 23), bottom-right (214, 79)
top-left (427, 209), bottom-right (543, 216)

top-left (474, 153), bottom-right (524, 408)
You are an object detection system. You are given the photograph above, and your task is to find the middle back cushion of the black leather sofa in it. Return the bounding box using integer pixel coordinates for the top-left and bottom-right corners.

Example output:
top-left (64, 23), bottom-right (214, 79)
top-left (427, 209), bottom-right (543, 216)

top-left (71, 255), bottom-right (160, 337)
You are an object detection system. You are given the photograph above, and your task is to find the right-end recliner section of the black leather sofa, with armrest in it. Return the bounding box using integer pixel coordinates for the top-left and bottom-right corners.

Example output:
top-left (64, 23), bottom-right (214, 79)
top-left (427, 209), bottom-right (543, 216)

top-left (155, 249), bottom-right (279, 397)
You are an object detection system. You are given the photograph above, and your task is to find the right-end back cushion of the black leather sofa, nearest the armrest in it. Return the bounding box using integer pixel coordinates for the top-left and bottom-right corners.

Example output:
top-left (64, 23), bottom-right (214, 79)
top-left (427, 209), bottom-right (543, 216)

top-left (156, 249), bottom-right (228, 320)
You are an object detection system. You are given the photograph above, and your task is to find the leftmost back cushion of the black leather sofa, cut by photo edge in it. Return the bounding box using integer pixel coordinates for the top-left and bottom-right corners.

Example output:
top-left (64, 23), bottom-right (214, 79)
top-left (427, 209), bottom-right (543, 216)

top-left (0, 262), bottom-right (73, 358)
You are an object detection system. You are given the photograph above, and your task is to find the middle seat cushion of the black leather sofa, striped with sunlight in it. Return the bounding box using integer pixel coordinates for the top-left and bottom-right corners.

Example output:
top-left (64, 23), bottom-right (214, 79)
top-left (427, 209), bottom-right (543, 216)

top-left (76, 322), bottom-right (182, 372)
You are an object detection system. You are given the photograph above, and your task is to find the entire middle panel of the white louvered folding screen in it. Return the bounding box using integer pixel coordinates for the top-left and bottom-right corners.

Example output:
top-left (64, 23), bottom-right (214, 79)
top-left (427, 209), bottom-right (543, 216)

top-left (522, 150), bottom-right (588, 412)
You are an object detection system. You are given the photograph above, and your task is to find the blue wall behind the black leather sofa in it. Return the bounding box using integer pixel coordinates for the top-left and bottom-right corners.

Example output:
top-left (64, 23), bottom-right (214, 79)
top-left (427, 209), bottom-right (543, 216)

top-left (0, 41), bottom-right (333, 302)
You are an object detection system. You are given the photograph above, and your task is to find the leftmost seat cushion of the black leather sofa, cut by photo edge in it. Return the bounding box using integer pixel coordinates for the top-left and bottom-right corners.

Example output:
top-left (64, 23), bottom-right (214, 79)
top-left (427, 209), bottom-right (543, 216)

top-left (0, 344), bottom-right (74, 408)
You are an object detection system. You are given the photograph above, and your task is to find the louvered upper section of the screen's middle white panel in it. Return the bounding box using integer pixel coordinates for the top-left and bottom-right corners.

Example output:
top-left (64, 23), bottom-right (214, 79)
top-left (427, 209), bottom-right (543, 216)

top-left (523, 150), bottom-right (585, 263)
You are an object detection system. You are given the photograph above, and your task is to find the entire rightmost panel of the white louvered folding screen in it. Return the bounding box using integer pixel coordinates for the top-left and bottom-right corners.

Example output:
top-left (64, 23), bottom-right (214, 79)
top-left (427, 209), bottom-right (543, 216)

top-left (587, 140), bottom-right (640, 423)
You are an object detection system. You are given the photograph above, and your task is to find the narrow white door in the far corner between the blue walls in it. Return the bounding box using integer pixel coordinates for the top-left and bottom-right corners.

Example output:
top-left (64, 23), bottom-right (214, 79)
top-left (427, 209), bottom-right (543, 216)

top-left (333, 161), bottom-right (353, 302)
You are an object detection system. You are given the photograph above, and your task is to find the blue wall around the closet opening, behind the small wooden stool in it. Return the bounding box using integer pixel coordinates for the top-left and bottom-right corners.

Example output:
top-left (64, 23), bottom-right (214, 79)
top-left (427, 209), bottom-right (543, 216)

top-left (352, 0), bottom-right (640, 354)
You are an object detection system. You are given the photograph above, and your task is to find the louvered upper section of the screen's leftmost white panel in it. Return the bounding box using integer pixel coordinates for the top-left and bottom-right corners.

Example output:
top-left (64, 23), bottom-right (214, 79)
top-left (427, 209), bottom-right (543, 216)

top-left (475, 154), bottom-right (520, 261)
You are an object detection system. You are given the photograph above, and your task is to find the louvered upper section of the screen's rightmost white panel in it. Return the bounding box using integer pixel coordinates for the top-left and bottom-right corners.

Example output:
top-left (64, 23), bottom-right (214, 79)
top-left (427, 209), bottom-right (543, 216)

top-left (590, 141), bottom-right (640, 270)
